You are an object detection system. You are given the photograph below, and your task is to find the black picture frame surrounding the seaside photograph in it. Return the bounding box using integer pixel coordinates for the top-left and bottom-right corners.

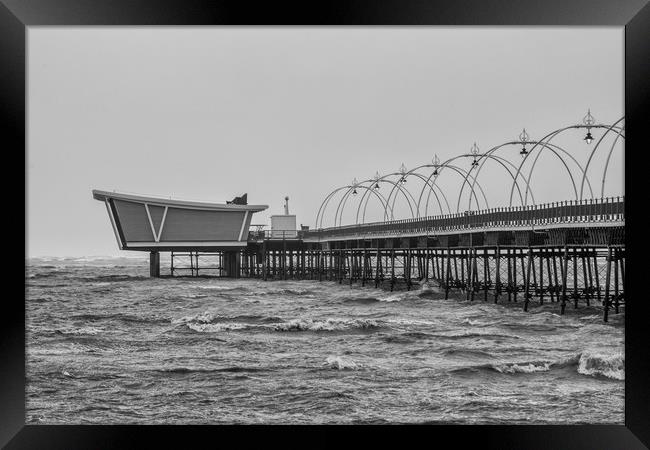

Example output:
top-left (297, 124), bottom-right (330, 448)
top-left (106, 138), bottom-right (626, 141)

top-left (0, 0), bottom-right (650, 449)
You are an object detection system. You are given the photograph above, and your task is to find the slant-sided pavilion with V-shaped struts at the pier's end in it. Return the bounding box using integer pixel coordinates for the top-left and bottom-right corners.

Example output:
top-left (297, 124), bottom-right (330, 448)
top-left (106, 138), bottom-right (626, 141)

top-left (93, 190), bottom-right (268, 277)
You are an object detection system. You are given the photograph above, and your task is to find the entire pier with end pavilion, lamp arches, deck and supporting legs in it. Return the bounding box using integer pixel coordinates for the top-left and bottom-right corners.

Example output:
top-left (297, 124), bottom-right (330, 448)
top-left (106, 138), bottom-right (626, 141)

top-left (93, 111), bottom-right (625, 321)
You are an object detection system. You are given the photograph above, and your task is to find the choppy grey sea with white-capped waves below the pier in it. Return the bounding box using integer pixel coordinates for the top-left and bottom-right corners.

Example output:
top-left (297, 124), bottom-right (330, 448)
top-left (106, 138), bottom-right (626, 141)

top-left (25, 257), bottom-right (625, 425)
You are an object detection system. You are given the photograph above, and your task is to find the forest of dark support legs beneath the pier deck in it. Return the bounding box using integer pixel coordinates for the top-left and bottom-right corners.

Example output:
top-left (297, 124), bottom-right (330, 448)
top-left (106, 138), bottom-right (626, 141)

top-left (151, 226), bottom-right (625, 320)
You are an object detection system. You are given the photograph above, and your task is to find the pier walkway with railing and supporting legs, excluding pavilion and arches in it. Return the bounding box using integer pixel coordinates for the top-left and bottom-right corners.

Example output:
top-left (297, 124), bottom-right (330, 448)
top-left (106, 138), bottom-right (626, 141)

top-left (162, 198), bottom-right (625, 321)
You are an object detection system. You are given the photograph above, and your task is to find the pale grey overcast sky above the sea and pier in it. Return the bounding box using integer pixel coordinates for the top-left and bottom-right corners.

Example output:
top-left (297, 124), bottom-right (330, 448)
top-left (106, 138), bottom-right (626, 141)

top-left (26, 27), bottom-right (624, 257)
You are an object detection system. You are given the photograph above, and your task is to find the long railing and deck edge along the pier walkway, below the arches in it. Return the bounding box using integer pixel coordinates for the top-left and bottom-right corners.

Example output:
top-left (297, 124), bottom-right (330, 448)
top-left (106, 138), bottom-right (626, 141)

top-left (298, 197), bottom-right (625, 239)
